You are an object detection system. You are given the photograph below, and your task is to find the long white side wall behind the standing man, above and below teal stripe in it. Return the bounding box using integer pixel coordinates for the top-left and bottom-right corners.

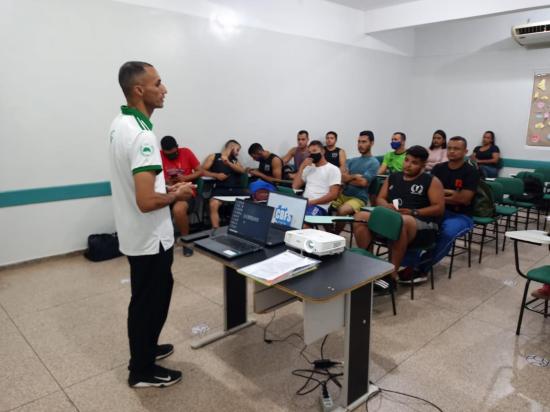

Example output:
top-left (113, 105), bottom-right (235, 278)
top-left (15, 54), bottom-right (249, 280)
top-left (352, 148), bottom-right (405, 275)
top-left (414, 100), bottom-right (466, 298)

top-left (0, 0), bottom-right (410, 265)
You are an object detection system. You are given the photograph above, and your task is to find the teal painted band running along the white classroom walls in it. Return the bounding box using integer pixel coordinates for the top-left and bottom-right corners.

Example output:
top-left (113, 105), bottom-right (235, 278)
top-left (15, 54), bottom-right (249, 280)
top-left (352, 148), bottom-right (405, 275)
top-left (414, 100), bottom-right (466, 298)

top-left (0, 156), bottom-right (550, 207)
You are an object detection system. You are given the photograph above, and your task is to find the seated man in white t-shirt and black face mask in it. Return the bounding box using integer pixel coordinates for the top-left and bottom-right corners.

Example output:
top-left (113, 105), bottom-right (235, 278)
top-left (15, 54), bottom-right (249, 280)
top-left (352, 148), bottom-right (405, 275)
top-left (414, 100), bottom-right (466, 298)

top-left (292, 140), bottom-right (342, 216)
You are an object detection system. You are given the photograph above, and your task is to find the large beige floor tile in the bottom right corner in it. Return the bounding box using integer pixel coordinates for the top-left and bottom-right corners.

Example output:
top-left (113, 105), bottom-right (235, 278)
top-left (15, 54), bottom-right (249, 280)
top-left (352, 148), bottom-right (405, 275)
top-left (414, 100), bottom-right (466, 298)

top-left (378, 319), bottom-right (550, 411)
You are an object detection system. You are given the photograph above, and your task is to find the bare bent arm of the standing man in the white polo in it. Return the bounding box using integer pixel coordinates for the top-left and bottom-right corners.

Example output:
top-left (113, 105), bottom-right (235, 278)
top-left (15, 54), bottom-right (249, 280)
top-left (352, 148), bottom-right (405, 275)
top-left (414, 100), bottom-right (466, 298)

top-left (134, 171), bottom-right (193, 213)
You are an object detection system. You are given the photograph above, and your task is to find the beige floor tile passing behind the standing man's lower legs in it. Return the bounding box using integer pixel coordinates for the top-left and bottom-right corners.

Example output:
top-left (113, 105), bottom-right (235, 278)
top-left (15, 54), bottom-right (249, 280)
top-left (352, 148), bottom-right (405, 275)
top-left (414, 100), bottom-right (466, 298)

top-left (15, 285), bottom-right (222, 387)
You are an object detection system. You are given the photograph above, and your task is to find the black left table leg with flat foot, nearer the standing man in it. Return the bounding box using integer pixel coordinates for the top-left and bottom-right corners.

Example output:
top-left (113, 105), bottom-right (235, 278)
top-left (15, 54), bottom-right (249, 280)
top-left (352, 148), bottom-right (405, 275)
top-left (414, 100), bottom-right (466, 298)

top-left (191, 266), bottom-right (256, 349)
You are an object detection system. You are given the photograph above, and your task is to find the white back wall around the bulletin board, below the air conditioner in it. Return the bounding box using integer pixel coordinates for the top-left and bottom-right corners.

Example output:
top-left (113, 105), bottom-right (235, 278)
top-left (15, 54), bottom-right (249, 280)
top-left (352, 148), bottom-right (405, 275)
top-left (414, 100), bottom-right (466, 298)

top-left (407, 9), bottom-right (550, 160)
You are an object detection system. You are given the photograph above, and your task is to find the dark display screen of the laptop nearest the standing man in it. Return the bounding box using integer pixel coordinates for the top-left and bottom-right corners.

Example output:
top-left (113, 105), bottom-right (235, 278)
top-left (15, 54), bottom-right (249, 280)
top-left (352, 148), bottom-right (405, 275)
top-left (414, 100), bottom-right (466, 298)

top-left (228, 199), bottom-right (273, 244)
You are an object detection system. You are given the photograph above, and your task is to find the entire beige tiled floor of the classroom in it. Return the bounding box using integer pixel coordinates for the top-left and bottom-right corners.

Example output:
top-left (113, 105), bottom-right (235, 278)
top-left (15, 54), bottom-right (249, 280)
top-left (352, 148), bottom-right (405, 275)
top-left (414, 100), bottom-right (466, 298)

top-left (0, 233), bottom-right (550, 412)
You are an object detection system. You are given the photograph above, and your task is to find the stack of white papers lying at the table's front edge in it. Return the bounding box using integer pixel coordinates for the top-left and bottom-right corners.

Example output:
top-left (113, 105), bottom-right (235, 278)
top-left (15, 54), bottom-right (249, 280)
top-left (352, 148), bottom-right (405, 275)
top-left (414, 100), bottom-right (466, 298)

top-left (237, 250), bottom-right (321, 285)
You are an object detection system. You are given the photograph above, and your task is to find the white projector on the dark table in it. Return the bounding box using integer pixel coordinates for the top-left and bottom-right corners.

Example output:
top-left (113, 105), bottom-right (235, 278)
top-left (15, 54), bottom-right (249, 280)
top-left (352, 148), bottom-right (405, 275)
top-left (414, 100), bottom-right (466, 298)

top-left (285, 229), bottom-right (346, 256)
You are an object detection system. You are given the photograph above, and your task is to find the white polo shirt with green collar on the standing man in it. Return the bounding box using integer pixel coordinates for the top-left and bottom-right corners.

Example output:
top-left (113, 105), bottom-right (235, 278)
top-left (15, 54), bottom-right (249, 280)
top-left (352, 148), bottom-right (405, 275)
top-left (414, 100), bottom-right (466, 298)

top-left (109, 106), bottom-right (174, 256)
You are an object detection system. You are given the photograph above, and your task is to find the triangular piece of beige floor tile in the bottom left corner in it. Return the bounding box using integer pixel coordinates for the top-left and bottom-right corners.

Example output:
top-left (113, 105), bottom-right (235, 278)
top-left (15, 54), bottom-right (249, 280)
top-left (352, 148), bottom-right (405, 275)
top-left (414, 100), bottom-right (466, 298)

top-left (0, 319), bottom-right (59, 411)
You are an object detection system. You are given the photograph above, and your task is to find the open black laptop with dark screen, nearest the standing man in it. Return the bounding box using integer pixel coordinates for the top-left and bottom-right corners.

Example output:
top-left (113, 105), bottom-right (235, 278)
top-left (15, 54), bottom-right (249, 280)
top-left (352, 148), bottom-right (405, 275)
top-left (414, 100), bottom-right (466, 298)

top-left (195, 199), bottom-right (273, 259)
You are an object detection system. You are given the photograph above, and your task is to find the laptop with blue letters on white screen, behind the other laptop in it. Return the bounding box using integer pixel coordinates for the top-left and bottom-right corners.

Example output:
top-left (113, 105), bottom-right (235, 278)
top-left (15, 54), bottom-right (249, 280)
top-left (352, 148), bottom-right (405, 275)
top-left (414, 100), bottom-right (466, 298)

top-left (266, 192), bottom-right (307, 246)
